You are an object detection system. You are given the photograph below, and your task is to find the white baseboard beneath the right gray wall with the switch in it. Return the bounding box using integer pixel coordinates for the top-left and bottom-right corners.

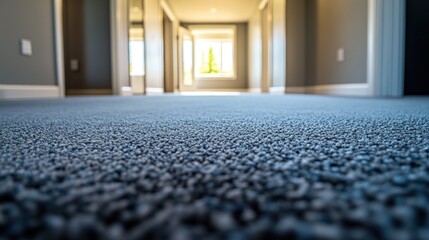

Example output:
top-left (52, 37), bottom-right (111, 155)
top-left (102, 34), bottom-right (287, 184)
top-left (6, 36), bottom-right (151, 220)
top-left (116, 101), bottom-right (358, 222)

top-left (286, 83), bottom-right (370, 96)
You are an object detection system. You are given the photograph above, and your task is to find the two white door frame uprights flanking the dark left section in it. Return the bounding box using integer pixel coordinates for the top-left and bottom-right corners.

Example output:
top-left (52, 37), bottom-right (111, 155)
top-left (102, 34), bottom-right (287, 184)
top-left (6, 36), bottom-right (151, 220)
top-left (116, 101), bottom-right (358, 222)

top-left (53, 0), bottom-right (131, 97)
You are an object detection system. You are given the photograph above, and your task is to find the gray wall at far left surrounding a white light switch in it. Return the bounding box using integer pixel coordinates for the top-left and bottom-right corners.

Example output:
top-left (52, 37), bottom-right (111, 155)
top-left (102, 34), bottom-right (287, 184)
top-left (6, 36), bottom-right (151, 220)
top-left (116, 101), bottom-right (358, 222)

top-left (0, 0), bottom-right (56, 85)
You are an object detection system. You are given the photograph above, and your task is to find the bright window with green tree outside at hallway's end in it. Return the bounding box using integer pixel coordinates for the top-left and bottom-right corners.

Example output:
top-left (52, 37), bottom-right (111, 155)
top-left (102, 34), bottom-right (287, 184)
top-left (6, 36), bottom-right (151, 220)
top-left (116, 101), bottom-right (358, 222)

top-left (191, 26), bottom-right (236, 79)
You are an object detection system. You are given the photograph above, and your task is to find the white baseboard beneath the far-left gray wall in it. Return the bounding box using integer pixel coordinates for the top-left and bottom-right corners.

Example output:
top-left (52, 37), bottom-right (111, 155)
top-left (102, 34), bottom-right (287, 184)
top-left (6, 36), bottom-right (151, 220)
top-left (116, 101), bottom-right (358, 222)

top-left (0, 84), bottom-right (61, 99)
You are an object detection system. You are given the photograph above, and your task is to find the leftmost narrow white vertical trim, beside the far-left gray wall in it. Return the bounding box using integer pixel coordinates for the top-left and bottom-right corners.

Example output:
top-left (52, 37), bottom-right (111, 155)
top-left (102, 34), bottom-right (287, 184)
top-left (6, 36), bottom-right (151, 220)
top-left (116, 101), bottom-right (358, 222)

top-left (54, 0), bottom-right (65, 97)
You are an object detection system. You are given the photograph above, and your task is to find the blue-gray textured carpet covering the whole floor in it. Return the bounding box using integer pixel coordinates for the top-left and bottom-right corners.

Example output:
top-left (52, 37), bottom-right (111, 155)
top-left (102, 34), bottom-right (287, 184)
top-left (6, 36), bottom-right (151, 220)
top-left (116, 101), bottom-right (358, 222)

top-left (0, 95), bottom-right (429, 240)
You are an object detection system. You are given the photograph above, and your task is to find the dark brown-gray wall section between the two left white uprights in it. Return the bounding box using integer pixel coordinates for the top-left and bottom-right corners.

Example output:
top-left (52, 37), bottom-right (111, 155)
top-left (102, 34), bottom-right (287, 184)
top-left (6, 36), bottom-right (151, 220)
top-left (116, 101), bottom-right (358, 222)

top-left (64, 0), bottom-right (112, 89)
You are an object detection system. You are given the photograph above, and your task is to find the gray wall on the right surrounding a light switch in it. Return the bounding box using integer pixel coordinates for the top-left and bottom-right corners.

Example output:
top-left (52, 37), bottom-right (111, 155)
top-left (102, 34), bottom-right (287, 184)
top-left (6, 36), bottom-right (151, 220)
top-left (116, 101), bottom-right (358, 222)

top-left (304, 0), bottom-right (368, 85)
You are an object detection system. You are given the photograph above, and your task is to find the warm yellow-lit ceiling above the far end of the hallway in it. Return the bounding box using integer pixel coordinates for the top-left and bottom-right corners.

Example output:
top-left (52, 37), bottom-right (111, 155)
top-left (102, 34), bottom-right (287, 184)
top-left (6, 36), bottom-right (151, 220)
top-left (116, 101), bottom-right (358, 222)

top-left (166, 0), bottom-right (261, 23)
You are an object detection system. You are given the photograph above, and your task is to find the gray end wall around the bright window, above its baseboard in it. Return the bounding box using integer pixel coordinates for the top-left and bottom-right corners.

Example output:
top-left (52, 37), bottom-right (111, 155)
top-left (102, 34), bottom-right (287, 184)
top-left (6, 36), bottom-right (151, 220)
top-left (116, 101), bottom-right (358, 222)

top-left (180, 23), bottom-right (248, 89)
